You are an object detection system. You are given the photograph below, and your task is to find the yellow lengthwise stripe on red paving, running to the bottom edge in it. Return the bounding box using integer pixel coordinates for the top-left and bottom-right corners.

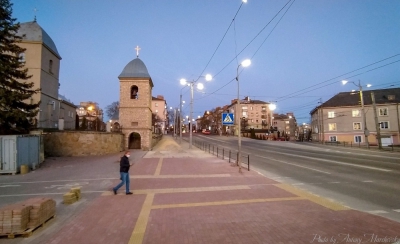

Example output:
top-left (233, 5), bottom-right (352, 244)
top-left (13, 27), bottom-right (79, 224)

top-left (128, 193), bottom-right (154, 244)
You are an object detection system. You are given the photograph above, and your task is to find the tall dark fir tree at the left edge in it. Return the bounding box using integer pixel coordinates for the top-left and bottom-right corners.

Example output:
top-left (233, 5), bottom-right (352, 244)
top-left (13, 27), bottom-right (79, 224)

top-left (0, 0), bottom-right (39, 134)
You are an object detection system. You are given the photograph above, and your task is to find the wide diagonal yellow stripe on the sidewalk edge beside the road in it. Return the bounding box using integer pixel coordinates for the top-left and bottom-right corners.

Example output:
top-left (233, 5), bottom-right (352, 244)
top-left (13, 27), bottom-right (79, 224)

top-left (275, 184), bottom-right (349, 211)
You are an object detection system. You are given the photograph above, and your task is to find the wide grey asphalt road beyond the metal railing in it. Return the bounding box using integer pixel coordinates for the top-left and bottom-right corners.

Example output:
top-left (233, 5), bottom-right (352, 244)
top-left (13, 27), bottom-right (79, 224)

top-left (190, 134), bottom-right (400, 222)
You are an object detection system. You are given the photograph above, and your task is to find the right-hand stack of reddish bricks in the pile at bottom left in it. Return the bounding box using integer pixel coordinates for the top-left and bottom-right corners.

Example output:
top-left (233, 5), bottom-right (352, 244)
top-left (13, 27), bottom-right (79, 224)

top-left (28, 198), bottom-right (56, 228)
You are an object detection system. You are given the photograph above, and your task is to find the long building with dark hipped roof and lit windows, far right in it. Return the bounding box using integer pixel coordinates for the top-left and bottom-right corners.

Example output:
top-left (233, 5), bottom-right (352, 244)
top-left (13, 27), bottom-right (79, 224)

top-left (310, 88), bottom-right (400, 146)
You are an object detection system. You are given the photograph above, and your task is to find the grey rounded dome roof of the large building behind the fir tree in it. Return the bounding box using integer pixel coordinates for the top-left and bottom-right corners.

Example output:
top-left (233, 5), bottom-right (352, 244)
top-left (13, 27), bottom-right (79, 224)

top-left (17, 21), bottom-right (61, 59)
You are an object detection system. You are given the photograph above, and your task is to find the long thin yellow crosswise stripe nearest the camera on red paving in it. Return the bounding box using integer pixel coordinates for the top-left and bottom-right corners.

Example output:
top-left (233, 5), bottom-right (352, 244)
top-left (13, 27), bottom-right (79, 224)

top-left (151, 197), bottom-right (305, 209)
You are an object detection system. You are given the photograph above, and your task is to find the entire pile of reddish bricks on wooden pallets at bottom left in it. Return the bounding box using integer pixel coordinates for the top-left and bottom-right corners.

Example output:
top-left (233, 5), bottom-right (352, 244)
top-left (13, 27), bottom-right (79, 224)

top-left (0, 198), bottom-right (56, 234)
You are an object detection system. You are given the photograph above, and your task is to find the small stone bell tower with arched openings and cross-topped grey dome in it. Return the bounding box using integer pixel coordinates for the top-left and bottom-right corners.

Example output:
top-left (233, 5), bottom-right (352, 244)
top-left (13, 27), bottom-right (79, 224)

top-left (118, 46), bottom-right (154, 151)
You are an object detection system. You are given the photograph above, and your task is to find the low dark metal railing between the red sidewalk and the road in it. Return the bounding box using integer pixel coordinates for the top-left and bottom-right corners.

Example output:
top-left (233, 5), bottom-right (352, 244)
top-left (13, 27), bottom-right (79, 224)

top-left (193, 140), bottom-right (250, 171)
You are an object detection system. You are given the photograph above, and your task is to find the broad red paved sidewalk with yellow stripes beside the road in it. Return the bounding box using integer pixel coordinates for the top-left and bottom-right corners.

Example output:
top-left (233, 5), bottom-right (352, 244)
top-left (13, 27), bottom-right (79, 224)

top-left (12, 136), bottom-right (400, 244)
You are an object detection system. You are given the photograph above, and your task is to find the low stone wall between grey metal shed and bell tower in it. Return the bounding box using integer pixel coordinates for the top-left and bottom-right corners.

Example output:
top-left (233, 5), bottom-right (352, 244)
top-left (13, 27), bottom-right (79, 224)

top-left (43, 131), bottom-right (124, 157)
